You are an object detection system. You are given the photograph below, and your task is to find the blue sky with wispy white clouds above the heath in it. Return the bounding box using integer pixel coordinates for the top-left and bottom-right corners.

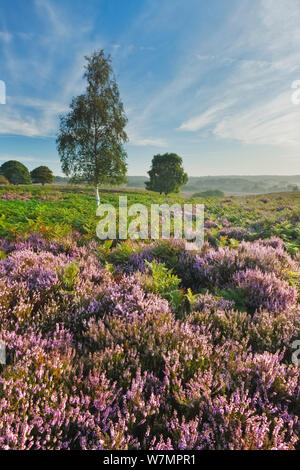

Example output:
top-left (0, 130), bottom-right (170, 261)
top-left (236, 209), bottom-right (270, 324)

top-left (0, 0), bottom-right (300, 176)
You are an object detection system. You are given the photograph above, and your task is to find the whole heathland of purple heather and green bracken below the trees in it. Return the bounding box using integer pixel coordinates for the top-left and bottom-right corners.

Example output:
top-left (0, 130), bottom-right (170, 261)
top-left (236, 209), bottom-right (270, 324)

top-left (0, 185), bottom-right (300, 450)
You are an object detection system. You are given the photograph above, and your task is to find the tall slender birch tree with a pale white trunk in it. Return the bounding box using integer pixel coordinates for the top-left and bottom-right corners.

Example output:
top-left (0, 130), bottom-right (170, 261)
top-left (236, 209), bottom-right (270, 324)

top-left (57, 50), bottom-right (128, 205)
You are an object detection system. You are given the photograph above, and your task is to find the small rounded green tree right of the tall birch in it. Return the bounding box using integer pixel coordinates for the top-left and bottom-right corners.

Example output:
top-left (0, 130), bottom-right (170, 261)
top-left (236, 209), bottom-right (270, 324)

top-left (146, 153), bottom-right (188, 194)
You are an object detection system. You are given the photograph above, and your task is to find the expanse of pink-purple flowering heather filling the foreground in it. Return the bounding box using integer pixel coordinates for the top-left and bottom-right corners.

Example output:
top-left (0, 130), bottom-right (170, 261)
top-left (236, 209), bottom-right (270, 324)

top-left (0, 237), bottom-right (300, 451)
